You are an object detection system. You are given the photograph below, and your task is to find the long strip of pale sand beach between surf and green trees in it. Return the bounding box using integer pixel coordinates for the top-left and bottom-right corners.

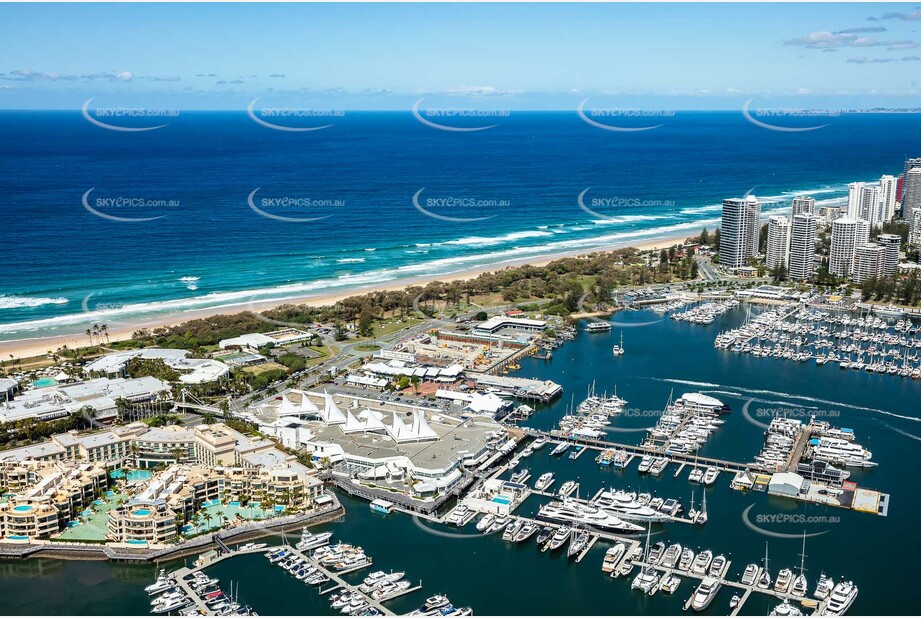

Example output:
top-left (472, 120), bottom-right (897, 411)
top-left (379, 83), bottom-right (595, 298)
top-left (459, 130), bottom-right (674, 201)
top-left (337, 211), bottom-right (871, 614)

top-left (0, 233), bottom-right (693, 360)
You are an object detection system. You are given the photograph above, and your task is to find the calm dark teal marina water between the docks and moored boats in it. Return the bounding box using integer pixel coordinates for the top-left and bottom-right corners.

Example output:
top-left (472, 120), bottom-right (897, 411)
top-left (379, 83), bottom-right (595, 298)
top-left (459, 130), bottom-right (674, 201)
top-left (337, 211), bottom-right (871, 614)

top-left (0, 307), bottom-right (921, 615)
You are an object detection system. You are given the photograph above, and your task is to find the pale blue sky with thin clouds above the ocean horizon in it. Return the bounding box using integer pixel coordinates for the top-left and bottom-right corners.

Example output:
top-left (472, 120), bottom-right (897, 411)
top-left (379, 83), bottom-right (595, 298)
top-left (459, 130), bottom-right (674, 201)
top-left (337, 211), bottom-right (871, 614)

top-left (0, 3), bottom-right (921, 110)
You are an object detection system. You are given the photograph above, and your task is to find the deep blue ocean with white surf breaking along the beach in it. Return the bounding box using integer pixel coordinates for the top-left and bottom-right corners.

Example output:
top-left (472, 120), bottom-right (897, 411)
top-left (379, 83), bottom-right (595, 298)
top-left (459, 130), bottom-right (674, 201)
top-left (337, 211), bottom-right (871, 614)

top-left (0, 111), bottom-right (921, 340)
